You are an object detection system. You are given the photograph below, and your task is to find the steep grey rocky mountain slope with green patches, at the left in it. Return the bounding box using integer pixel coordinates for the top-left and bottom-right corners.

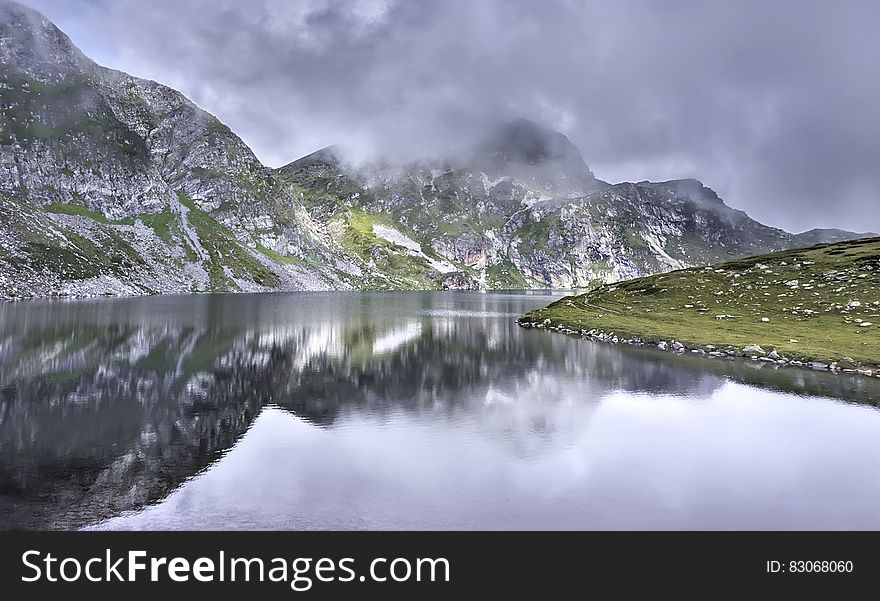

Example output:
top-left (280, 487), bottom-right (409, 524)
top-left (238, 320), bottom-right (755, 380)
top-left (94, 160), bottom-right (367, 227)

top-left (0, 2), bottom-right (360, 295)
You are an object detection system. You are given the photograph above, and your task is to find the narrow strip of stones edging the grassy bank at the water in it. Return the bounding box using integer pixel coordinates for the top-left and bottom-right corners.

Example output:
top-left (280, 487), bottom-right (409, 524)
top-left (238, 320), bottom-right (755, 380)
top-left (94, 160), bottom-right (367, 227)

top-left (517, 317), bottom-right (880, 378)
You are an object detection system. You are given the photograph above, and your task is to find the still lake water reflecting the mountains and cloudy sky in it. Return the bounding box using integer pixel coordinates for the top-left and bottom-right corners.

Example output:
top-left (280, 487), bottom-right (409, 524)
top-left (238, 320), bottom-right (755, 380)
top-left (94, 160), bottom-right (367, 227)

top-left (0, 292), bottom-right (880, 529)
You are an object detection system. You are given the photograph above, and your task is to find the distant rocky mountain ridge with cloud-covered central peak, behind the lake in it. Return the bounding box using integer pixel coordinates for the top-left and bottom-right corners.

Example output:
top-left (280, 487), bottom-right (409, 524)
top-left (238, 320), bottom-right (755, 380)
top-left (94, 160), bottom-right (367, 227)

top-left (277, 125), bottom-right (872, 288)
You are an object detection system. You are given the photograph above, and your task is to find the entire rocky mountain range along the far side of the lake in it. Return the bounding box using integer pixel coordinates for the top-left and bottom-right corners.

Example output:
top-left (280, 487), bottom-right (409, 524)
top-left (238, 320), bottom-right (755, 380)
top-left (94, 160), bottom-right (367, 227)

top-left (0, 0), bottom-right (868, 297)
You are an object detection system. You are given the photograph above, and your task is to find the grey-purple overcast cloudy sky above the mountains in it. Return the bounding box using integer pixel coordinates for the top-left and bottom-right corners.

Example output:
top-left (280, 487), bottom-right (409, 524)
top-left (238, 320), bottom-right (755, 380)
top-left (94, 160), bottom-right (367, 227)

top-left (13, 0), bottom-right (880, 232)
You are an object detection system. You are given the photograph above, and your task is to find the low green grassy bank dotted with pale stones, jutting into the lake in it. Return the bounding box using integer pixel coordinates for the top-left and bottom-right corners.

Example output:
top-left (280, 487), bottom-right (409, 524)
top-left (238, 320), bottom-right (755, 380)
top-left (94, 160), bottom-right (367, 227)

top-left (520, 238), bottom-right (880, 371)
